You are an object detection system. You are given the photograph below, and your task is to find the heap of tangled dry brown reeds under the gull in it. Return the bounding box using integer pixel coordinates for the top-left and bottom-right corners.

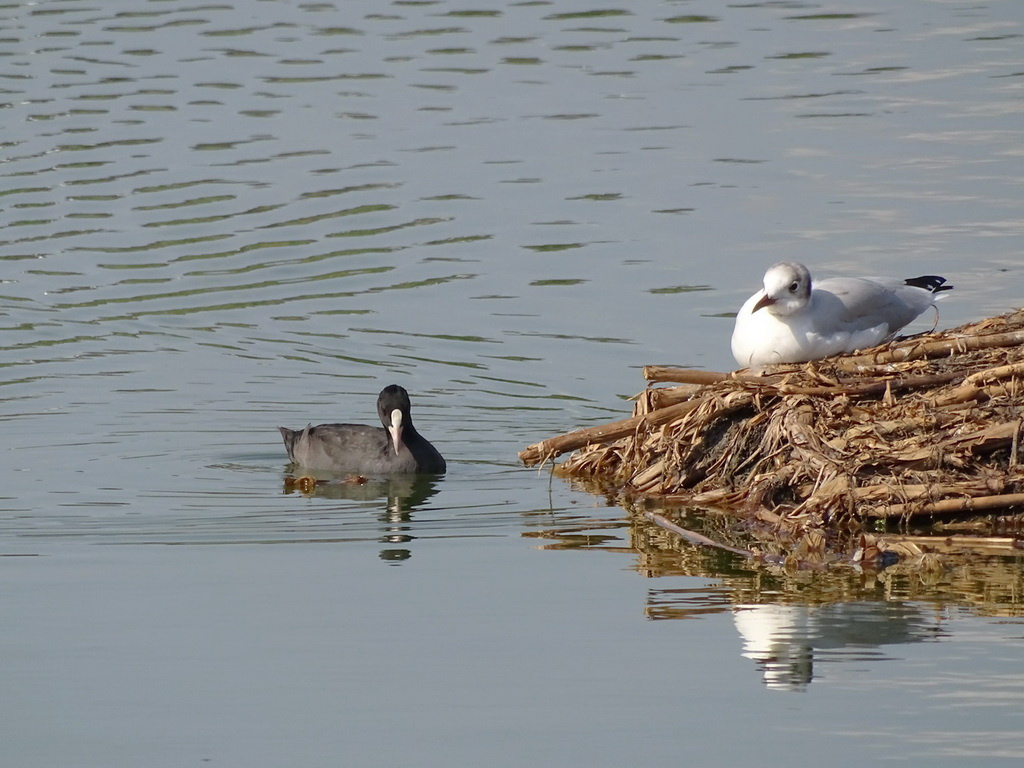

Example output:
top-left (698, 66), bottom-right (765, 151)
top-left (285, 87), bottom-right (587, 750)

top-left (519, 310), bottom-right (1024, 565)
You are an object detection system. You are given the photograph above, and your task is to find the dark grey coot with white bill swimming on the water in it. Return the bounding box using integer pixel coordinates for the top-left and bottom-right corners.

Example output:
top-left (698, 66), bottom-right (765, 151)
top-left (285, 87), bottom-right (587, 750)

top-left (278, 384), bottom-right (446, 475)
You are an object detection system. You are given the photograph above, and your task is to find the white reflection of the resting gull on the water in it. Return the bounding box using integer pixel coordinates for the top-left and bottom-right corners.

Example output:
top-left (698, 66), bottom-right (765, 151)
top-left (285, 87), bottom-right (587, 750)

top-left (732, 602), bottom-right (941, 690)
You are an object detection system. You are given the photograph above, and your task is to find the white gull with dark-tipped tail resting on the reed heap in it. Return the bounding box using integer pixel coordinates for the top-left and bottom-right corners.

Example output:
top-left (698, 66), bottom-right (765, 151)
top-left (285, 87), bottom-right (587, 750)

top-left (732, 261), bottom-right (952, 368)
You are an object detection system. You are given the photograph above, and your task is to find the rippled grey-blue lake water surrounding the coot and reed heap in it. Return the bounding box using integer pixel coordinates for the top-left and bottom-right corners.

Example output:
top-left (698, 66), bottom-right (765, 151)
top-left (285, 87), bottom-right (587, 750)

top-left (0, 0), bottom-right (1024, 767)
